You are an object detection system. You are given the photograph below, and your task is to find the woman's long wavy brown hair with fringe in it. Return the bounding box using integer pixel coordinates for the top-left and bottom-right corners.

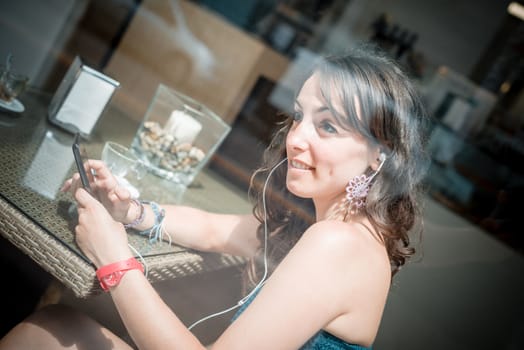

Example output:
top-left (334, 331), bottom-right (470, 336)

top-left (247, 45), bottom-right (428, 283)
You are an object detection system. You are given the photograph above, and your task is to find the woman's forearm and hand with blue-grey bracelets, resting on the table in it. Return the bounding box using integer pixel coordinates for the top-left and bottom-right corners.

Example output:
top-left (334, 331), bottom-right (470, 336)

top-left (62, 159), bottom-right (259, 257)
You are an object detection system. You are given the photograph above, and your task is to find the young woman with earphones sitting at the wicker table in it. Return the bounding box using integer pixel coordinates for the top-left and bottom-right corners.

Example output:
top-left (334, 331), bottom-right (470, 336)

top-left (0, 44), bottom-right (426, 350)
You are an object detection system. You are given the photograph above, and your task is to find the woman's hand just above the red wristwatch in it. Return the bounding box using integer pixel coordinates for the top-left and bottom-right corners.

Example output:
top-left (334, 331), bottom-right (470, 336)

top-left (75, 188), bottom-right (133, 267)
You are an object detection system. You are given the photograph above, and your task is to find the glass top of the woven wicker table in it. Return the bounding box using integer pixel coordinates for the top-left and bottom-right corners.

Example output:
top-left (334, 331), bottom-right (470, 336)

top-left (0, 90), bottom-right (250, 261)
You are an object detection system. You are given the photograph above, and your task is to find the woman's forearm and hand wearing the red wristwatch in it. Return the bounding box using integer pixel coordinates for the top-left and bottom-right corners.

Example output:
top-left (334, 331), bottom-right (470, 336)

top-left (75, 189), bottom-right (203, 349)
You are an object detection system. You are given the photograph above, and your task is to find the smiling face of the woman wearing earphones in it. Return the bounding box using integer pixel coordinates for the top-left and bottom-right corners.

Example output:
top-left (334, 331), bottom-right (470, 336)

top-left (286, 74), bottom-right (377, 205)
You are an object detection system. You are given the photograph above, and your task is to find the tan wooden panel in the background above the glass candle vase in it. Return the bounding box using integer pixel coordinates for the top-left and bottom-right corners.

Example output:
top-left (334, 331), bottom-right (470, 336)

top-left (105, 0), bottom-right (288, 123)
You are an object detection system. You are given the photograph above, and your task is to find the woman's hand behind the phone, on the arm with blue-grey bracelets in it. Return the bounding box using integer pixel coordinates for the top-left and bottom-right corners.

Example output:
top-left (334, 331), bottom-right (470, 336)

top-left (62, 159), bottom-right (136, 223)
